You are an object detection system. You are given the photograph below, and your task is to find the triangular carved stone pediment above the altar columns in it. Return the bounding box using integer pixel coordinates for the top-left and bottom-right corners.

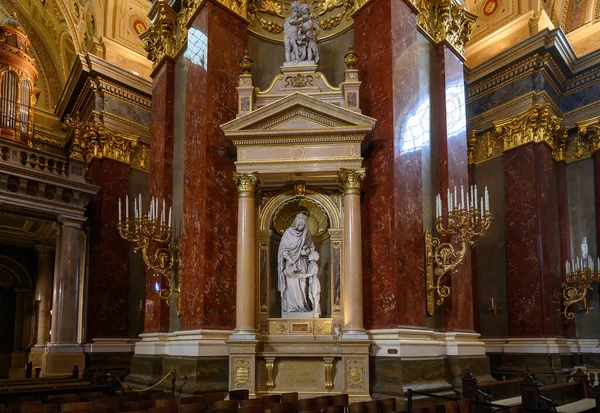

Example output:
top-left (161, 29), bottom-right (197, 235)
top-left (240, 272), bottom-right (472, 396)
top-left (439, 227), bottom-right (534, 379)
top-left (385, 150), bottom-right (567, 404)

top-left (221, 93), bottom-right (375, 138)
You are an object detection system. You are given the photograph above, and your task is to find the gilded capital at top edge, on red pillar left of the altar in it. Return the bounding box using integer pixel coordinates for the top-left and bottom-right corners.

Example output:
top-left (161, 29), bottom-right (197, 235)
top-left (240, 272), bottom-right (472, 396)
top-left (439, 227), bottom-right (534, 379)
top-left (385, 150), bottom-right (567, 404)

top-left (140, 0), bottom-right (177, 66)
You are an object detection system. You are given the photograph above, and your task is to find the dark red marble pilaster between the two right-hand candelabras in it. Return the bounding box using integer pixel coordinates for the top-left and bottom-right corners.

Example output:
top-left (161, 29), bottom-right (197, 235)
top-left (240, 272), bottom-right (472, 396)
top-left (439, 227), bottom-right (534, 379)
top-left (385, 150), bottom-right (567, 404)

top-left (503, 144), bottom-right (562, 337)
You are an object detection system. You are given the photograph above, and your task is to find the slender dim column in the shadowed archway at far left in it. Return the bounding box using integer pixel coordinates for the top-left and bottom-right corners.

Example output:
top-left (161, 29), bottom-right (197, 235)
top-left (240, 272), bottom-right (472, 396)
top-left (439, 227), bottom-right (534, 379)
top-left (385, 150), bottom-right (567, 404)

top-left (35, 245), bottom-right (54, 346)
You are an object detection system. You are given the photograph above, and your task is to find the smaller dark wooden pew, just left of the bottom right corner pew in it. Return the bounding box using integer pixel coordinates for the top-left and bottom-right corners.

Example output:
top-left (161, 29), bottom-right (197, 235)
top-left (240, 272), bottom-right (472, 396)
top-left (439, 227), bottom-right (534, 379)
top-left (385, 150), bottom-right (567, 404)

top-left (462, 372), bottom-right (523, 407)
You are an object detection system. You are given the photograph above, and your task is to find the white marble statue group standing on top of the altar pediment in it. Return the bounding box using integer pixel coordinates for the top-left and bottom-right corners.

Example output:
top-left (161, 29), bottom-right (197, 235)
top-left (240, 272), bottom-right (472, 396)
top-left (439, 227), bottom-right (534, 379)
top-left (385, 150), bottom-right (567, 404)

top-left (283, 0), bottom-right (319, 66)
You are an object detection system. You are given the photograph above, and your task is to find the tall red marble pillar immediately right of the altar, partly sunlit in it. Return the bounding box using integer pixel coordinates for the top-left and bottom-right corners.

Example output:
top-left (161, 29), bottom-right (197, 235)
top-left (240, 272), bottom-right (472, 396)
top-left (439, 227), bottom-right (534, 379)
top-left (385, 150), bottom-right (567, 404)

top-left (354, 0), bottom-right (429, 328)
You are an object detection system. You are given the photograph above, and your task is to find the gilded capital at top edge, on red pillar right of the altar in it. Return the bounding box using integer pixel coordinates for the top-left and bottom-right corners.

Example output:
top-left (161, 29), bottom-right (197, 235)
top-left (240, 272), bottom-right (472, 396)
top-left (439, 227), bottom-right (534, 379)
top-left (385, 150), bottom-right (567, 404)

top-left (412, 0), bottom-right (477, 54)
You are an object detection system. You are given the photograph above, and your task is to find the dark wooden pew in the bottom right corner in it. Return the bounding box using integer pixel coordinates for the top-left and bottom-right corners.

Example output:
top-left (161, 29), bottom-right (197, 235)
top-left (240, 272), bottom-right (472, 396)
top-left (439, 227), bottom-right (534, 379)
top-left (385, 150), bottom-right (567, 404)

top-left (521, 369), bottom-right (600, 413)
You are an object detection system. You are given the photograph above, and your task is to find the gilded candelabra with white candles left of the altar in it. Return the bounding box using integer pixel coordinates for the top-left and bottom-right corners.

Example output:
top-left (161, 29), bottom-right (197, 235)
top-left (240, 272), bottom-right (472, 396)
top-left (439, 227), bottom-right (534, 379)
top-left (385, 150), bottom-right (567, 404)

top-left (117, 194), bottom-right (182, 316)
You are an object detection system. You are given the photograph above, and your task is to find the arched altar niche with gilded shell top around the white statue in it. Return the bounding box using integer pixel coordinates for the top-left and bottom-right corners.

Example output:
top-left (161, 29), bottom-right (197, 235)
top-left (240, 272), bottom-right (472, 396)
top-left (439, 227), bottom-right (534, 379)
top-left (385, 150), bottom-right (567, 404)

top-left (258, 188), bottom-right (343, 334)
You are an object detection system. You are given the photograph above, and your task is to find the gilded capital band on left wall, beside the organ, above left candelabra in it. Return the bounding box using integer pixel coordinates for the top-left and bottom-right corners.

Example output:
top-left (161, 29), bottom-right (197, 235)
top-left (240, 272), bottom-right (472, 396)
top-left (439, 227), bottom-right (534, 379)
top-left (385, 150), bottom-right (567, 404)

top-left (65, 113), bottom-right (139, 169)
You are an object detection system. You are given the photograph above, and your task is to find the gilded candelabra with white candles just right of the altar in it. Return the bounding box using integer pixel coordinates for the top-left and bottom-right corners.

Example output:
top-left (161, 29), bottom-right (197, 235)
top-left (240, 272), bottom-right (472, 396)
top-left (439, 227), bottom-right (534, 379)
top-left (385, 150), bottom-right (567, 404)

top-left (425, 185), bottom-right (492, 316)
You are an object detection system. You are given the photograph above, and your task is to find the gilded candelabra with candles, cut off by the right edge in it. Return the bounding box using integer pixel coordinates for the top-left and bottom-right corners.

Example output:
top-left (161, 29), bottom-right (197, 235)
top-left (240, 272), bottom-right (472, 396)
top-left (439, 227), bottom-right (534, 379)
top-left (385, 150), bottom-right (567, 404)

top-left (554, 257), bottom-right (600, 323)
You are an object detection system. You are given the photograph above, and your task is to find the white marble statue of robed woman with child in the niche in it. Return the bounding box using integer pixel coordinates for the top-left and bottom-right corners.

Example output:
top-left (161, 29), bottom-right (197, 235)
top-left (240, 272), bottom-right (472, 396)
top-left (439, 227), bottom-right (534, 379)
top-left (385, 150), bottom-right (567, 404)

top-left (277, 213), bottom-right (321, 317)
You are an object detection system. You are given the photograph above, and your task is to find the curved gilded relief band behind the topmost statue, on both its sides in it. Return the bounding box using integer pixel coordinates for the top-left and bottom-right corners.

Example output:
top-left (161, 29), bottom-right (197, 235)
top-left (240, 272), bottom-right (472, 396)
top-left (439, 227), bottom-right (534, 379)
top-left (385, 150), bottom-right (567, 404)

top-left (248, 0), bottom-right (358, 43)
